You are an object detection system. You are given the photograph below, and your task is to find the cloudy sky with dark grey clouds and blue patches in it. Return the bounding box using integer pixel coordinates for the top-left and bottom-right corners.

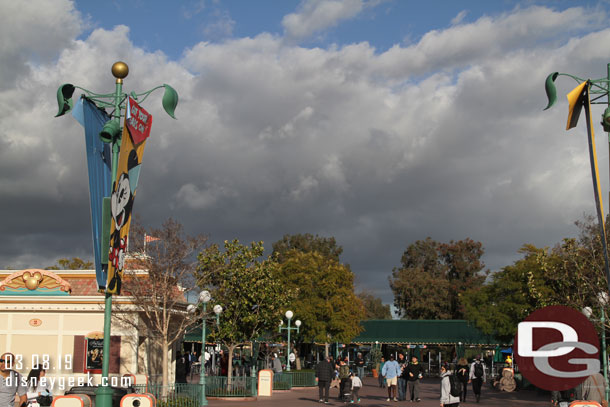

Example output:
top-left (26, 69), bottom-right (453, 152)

top-left (0, 0), bottom-right (610, 310)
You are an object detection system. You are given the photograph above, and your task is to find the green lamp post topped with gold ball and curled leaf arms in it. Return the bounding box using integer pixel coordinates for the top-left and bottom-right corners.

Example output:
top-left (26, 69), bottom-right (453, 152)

top-left (55, 61), bottom-right (178, 407)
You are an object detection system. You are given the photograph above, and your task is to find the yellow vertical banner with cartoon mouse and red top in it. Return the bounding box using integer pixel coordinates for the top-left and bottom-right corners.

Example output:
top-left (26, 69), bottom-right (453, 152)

top-left (106, 98), bottom-right (152, 294)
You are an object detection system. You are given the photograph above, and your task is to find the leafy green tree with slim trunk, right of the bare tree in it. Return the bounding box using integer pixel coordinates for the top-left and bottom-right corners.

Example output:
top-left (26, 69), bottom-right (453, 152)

top-left (196, 240), bottom-right (292, 383)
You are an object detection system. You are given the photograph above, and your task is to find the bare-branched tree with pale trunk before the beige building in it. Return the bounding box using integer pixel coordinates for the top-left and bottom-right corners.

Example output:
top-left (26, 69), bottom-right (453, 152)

top-left (113, 219), bottom-right (207, 386)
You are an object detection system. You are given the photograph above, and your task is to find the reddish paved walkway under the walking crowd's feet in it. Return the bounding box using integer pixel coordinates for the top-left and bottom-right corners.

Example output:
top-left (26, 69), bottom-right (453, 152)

top-left (209, 377), bottom-right (550, 407)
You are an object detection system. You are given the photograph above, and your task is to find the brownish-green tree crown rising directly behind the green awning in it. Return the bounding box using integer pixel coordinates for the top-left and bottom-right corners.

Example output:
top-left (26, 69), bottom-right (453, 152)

top-left (390, 237), bottom-right (487, 319)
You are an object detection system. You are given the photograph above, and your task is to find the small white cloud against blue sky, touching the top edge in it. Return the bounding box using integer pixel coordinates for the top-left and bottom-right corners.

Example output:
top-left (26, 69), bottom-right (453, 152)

top-left (282, 0), bottom-right (364, 39)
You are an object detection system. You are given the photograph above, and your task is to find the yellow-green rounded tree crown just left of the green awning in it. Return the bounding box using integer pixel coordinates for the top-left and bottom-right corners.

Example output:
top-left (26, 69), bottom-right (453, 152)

top-left (276, 249), bottom-right (365, 350)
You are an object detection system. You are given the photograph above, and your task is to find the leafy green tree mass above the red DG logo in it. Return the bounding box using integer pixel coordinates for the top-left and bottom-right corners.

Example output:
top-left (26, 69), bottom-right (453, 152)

top-left (462, 218), bottom-right (607, 342)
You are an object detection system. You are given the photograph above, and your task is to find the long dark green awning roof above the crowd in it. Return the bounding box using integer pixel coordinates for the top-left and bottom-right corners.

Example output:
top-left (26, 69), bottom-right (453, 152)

top-left (352, 319), bottom-right (502, 345)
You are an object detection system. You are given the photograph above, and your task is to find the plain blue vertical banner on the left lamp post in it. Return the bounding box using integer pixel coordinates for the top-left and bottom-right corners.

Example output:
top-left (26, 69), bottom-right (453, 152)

top-left (72, 97), bottom-right (112, 291)
